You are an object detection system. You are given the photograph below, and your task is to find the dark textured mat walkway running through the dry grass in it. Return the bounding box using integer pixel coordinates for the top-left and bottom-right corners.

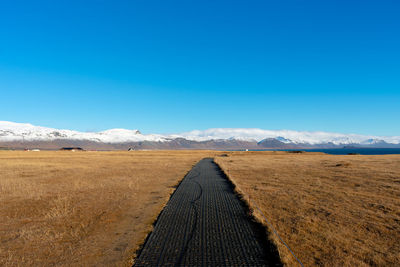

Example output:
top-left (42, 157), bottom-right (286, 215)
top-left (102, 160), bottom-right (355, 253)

top-left (135, 158), bottom-right (280, 266)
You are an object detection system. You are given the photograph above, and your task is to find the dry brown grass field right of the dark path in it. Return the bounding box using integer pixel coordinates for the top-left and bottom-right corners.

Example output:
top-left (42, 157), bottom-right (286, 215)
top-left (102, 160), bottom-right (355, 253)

top-left (216, 152), bottom-right (400, 266)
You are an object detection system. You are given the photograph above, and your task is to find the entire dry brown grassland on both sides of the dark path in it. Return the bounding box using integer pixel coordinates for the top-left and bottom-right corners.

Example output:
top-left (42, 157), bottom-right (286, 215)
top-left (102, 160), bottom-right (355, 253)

top-left (0, 151), bottom-right (400, 266)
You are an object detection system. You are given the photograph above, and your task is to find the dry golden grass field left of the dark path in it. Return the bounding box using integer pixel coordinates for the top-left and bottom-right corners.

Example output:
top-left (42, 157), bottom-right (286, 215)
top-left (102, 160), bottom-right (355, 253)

top-left (0, 151), bottom-right (213, 266)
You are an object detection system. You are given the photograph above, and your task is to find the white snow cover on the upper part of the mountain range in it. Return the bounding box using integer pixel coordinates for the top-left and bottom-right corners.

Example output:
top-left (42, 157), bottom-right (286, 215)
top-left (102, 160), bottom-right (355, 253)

top-left (0, 121), bottom-right (400, 145)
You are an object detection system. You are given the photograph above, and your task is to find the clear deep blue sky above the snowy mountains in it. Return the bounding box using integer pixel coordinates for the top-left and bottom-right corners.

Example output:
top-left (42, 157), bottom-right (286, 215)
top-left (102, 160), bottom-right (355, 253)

top-left (0, 0), bottom-right (400, 135)
